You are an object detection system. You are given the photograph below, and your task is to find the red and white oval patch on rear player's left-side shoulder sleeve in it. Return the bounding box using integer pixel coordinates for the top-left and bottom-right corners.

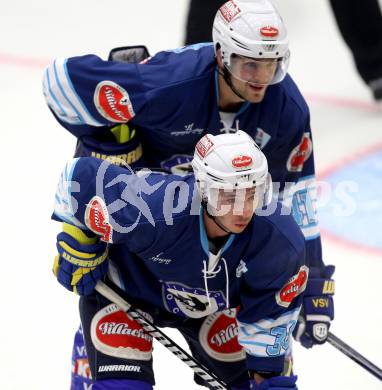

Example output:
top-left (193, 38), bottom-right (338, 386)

top-left (94, 80), bottom-right (135, 123)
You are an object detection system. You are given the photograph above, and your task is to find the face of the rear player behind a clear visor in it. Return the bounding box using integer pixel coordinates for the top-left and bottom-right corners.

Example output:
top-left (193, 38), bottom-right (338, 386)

top-left (228, 55), bottom-right (278, 103)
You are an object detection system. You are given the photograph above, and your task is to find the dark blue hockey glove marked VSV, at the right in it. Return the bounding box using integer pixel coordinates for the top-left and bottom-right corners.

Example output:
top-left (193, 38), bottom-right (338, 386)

top-left (293, 265), bottom-right (335, 348)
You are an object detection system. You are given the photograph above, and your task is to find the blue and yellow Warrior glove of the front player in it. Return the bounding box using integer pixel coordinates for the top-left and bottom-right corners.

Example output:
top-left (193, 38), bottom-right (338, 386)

top-left (53, 224), bottom-right (108, 295)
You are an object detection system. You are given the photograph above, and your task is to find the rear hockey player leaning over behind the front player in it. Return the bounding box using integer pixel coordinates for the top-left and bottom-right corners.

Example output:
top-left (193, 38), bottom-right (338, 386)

top-left (44, 0), bottom-right (333, 386)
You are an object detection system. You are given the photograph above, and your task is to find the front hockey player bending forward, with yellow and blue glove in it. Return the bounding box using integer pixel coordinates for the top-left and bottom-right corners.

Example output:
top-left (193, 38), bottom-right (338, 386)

top-left (54, 131), bottom-right (316, 390)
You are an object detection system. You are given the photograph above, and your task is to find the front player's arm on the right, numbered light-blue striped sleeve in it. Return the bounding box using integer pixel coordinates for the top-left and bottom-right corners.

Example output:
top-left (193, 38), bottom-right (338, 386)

top-left (237, 227), bottom-right (309, 390)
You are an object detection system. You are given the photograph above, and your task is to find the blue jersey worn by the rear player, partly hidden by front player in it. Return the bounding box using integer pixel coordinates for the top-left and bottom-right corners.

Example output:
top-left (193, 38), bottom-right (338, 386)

top-left (44, 44), bottom-right (323, 267)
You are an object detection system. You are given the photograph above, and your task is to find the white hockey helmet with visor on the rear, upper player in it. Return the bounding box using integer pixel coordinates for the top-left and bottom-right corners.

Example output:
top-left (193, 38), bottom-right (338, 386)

top-left (212, 0), bottom-right (290, 85)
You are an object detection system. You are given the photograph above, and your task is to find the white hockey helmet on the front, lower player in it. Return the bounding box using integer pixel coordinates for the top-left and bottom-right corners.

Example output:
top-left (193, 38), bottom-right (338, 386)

top-left (191, 130), bottom-right (272, 212)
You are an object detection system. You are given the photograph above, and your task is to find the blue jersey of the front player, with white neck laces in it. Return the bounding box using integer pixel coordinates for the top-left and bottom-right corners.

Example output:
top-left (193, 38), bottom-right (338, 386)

top-left (55, 158), bottom-right (308, 372)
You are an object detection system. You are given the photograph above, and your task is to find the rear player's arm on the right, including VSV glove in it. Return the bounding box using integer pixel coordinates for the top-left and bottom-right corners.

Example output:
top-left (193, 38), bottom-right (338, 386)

top-left (273, 101), bottom-right (334, 347)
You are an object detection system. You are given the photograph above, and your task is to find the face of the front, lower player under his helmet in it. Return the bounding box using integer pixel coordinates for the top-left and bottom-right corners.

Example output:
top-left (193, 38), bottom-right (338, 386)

top-left (215, 188), bottom-right (258, 233)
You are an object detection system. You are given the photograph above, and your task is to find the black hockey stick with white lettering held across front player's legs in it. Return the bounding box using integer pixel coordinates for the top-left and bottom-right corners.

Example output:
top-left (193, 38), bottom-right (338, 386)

top-left (95, 281), bottom-right (228, 390)
